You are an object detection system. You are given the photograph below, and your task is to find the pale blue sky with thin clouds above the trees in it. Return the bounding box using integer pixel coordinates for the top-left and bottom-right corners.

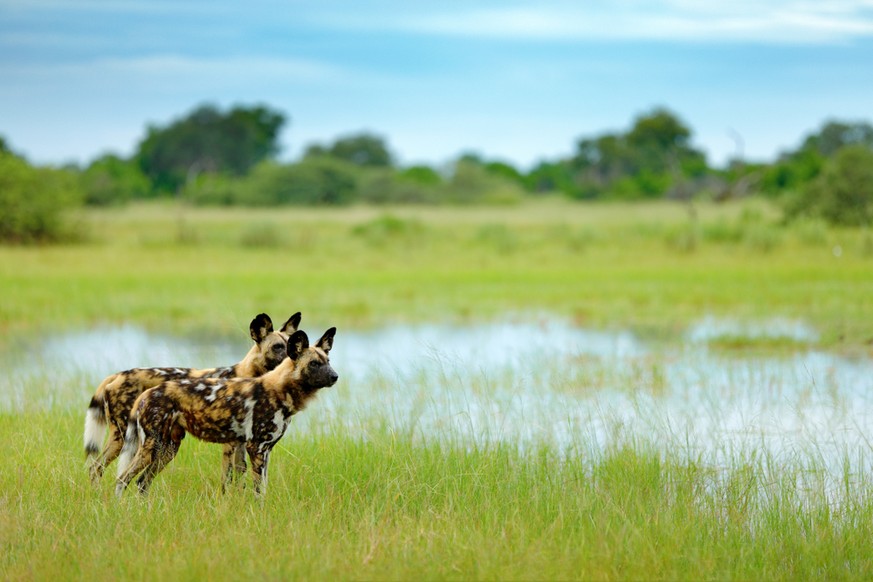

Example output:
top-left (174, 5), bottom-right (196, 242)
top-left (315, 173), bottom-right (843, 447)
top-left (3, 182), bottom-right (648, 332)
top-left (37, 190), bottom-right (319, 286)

top-left (0, 0), bottom-right (873, 168)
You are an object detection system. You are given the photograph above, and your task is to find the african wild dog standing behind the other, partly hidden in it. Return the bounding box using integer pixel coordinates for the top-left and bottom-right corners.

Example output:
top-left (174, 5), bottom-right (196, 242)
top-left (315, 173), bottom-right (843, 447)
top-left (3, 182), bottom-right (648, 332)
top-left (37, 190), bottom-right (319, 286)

top-left (85, 312), bottom-right (301, 484)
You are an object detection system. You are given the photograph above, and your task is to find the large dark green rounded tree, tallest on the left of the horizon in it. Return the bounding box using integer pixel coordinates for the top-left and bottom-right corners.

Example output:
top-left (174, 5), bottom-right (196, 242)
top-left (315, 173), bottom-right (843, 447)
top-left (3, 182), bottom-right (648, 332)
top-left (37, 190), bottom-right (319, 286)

top-left (136, 105), bottom-right (285, 193)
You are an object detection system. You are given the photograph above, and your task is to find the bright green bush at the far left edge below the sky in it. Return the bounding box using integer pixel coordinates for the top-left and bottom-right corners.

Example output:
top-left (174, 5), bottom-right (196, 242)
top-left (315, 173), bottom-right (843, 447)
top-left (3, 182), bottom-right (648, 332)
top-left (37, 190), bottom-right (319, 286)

top-left (0, 151), bottom-right (81, 243)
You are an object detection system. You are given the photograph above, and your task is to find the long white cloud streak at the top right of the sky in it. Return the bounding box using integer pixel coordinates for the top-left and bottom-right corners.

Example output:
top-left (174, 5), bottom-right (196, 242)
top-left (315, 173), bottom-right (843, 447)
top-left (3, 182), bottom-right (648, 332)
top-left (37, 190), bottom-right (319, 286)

top-left (346, 0), bottom-right (873, 44)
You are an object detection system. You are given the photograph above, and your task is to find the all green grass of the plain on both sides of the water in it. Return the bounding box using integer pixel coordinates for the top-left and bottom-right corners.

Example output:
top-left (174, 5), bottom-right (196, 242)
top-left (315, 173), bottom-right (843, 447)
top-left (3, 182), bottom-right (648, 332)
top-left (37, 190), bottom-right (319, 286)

top-left (0, 200), bottom-right (873, 580)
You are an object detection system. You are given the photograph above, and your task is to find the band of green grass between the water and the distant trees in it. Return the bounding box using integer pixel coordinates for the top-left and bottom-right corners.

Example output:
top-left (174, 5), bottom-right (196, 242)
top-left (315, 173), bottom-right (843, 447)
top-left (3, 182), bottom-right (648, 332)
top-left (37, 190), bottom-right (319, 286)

top-left (0, 200), bottom-right (873, 351)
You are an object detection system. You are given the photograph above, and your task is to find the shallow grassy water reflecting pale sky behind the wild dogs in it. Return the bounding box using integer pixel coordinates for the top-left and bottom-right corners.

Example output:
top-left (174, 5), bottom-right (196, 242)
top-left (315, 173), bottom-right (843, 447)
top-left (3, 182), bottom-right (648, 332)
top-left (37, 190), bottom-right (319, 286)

top-left (0, 319), bottom-right (873, 480)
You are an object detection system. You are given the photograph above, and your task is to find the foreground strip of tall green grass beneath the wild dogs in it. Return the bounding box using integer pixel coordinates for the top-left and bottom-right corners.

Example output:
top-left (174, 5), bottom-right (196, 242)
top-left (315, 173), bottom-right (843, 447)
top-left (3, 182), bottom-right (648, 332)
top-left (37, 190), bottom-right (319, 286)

top-left (0, 413), bottom-right (873, 580)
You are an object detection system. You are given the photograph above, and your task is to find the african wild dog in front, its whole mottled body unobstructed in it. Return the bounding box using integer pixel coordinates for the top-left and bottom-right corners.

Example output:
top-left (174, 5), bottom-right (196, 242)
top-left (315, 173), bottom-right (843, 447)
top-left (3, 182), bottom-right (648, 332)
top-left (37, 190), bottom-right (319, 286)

top-left (115, 327), bottom-right (339, 497)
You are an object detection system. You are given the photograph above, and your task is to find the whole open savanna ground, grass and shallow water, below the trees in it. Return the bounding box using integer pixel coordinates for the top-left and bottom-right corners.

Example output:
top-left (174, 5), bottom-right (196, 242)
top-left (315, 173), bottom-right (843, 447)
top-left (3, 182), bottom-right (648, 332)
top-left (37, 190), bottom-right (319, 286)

top-left (0, 199), bottom-right (873, 580)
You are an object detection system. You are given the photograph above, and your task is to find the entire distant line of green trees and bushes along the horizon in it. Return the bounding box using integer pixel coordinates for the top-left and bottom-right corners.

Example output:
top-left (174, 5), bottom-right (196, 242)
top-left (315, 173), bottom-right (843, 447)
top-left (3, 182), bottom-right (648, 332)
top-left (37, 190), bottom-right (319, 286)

top-left (0, 105), bottom-right (873, 241)
